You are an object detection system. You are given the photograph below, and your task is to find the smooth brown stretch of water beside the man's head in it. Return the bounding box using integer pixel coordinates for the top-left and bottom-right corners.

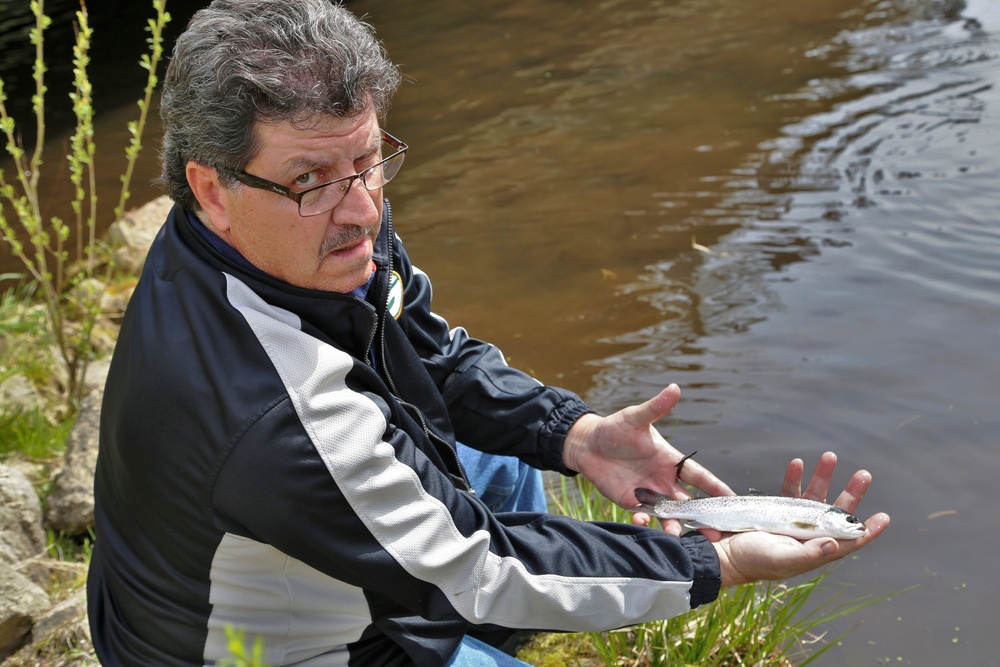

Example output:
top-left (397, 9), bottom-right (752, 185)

top-left (368, 0), bottom-right (876, 390)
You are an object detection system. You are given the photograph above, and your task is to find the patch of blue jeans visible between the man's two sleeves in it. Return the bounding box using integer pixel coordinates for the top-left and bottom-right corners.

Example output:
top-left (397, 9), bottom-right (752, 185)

top-left (457, 443), bottom-right (548, 512)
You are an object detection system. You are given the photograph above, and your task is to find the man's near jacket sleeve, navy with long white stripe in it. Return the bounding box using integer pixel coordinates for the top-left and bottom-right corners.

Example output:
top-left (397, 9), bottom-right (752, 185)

top-left (212, 272), bottom-right (720, 656)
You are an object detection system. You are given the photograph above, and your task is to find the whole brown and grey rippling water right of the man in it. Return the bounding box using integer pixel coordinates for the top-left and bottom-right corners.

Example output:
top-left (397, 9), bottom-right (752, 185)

top-left (0, 0), bottom-right (1000, 666)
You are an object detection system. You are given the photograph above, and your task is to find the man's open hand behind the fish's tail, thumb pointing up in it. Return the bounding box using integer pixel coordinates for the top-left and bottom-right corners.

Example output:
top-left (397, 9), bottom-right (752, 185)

top-left (563, 384), bottom-right (733, 539)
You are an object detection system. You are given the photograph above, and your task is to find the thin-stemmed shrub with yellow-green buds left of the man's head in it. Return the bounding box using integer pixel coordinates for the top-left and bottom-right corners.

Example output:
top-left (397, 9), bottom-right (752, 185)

top-left (0, 0), bottom-right (170, 412)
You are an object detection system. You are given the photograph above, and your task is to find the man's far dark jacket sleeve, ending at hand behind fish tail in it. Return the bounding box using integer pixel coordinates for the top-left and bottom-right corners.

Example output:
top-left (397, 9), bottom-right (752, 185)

top-left (394, 236), bottom-right (593, 475)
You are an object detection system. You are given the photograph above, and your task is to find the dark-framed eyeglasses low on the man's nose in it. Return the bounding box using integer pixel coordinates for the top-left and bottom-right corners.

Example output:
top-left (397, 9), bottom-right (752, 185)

top-left (216, 130), bottom-right (409, 217)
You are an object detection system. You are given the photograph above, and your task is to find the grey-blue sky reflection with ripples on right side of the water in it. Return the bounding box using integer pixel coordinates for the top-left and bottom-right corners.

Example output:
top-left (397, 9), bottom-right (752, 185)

top-left (589, 3), bottom-right (1000, 665)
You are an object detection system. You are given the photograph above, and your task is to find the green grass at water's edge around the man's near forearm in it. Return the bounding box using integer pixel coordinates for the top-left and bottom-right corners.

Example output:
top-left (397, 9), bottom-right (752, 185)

top-left (518, 478), bottom-right (904, 667)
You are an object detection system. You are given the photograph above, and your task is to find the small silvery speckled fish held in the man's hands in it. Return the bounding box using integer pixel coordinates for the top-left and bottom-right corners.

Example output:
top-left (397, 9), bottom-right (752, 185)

top-left (629, 488), bottom-right (867, 540)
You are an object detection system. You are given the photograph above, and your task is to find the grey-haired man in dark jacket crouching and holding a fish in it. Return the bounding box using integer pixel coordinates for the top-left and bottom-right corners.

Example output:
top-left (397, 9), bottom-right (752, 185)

top-left (88, 0), bottom-right (888, 666)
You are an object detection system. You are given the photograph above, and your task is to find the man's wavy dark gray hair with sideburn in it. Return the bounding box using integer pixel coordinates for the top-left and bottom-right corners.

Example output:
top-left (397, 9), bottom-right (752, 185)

top-left (160, 0), bottom-right (401, 210)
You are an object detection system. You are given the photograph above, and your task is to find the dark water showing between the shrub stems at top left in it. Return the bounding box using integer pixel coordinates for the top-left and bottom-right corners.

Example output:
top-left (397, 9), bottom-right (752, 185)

top-left (0, 0), bottom-right (207, 276)
